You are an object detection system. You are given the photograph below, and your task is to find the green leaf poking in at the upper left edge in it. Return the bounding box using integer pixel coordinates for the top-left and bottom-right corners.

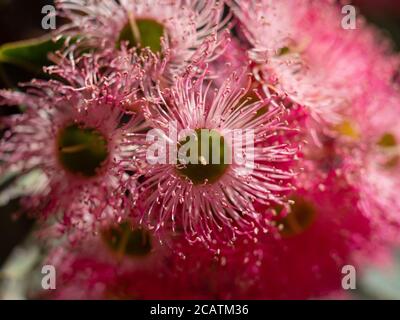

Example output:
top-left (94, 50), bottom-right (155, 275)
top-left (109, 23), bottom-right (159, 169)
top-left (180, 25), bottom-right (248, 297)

top-left (0, 35), bottom-right (64, 73)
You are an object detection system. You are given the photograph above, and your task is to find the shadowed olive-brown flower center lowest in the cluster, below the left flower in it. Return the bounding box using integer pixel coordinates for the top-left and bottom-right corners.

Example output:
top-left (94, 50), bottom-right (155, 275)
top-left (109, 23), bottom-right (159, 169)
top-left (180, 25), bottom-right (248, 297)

top-left (102, 222), bottom-right (153, 257)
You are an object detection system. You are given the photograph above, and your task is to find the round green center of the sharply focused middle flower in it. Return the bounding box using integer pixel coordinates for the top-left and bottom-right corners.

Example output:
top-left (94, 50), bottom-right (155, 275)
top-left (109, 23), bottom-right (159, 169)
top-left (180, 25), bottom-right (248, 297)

top-left (177, 129), bottom-right (229, 184)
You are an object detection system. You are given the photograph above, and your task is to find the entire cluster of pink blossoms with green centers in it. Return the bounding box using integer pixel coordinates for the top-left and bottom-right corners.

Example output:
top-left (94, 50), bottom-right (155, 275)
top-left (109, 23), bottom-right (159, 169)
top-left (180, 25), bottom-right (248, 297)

top-left (0, 0), bottom-right (400, 299)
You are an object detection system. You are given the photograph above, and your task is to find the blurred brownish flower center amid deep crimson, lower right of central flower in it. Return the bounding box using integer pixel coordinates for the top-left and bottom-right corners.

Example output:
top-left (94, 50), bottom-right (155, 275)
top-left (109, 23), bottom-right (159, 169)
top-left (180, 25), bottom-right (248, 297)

top-left (279, 197), bottom-right (316, 237)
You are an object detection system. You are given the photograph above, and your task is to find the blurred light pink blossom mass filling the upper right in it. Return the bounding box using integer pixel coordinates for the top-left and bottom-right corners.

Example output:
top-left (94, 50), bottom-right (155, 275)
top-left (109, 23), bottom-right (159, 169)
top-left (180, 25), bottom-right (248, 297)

top-left (233, 0), bottom-right (399, 245)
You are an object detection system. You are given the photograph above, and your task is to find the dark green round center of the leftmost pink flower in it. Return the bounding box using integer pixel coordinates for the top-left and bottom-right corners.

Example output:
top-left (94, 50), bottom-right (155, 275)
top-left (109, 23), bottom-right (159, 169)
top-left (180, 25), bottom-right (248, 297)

top-left (57, 124), bottom-right (108, 177)
